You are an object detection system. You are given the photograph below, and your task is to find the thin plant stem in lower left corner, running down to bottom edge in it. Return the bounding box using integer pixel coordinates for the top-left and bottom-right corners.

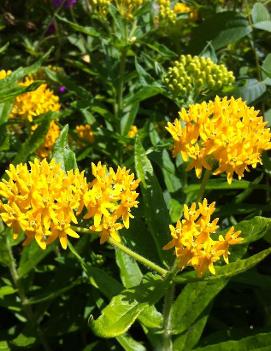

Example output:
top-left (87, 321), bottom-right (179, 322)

top-left (6, 238), bottom-right (51, 351)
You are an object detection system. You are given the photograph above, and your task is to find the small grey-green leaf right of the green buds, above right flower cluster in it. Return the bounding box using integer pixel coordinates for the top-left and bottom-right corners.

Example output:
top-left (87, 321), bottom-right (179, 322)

top-left (233, 79), bottom-right (266, 104)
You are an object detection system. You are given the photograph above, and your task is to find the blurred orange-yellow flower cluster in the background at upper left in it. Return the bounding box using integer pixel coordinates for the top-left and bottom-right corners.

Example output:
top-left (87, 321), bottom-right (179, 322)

top-left (0, 70), bottom-right (60, 122)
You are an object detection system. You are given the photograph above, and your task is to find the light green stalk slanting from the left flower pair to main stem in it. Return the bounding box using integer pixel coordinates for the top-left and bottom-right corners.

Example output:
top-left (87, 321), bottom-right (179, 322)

top-left (72, 227), bottom-right (168, 276)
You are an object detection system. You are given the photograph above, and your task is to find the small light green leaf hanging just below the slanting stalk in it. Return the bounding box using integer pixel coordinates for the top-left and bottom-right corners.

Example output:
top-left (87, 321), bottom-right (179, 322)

top-left (116, 249), bottom-right (143, 289)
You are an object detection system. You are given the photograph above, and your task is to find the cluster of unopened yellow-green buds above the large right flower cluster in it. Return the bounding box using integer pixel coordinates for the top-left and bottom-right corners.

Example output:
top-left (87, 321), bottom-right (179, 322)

top-left (164, 55), bottom-right (235, 97)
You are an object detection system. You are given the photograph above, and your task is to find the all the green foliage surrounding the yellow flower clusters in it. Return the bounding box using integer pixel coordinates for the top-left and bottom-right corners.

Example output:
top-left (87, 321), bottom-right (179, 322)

top-left (0, 0), bottom-right (271, 351)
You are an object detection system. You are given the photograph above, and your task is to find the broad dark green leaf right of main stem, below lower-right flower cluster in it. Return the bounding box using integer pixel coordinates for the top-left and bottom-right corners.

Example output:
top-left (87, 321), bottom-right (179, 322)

top-left (171, 279), bottom-right (228, 334)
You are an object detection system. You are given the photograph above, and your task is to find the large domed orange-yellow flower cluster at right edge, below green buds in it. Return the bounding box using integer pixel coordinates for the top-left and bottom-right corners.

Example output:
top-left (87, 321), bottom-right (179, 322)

top-left (166, 97), bottom-right (271, 183)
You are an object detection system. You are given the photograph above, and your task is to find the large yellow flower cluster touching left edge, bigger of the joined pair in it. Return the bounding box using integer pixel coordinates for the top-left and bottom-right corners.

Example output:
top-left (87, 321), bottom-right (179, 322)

top-left (0, 159), bottom-right (88, 249)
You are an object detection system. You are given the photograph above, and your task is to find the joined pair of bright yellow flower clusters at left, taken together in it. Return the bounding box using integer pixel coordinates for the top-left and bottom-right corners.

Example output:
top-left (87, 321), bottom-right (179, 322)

top-left (0, 159), bottom-right (138, 249)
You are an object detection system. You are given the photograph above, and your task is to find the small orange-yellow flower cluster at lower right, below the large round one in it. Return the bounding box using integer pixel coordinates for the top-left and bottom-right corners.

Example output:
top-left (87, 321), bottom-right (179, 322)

top-left (164, 199), bottom-right (243, 276)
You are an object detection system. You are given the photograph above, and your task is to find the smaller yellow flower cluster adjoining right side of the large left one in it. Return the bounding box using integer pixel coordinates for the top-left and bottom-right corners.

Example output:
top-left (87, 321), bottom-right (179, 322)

top-left (84, 162), bottom-right (139, 243)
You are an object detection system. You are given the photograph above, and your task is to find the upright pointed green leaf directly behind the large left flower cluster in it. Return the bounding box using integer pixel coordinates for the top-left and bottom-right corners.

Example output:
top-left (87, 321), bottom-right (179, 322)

top-left (52, 124), bottom-right (77, 171)
